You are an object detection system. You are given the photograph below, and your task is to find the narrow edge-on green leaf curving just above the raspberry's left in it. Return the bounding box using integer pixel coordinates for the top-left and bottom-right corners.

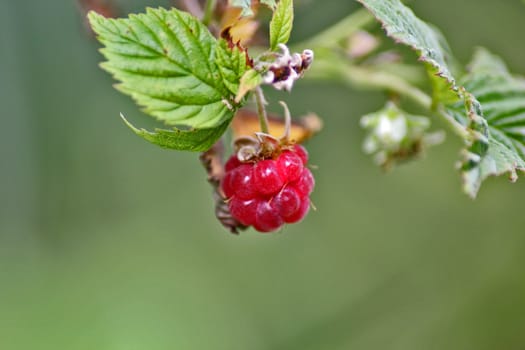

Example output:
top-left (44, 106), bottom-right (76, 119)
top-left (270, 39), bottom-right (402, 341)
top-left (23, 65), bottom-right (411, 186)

top-left (120, 114), bottom-right (229, 152)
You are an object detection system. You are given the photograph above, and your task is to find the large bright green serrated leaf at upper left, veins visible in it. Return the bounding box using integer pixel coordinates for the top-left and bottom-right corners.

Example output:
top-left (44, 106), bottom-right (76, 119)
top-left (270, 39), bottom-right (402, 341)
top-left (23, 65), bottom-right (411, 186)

top-left (88, 8), bottom-right (240, 128)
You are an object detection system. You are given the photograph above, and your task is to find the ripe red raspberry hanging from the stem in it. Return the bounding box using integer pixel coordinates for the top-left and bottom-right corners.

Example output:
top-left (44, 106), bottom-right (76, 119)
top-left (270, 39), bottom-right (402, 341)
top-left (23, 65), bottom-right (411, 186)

top-left (221, 145), bottom-right (315, 232)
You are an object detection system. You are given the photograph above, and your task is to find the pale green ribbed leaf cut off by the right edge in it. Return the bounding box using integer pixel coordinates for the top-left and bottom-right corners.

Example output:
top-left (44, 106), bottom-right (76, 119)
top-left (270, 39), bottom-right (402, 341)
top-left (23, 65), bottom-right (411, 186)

top-left (451, 49), bottom-right (525, 197)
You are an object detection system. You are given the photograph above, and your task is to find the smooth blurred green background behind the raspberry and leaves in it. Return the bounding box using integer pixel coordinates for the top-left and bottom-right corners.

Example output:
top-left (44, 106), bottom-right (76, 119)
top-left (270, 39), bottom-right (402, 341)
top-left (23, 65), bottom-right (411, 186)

top-left (0, 0), bottom-right (525, 350)
